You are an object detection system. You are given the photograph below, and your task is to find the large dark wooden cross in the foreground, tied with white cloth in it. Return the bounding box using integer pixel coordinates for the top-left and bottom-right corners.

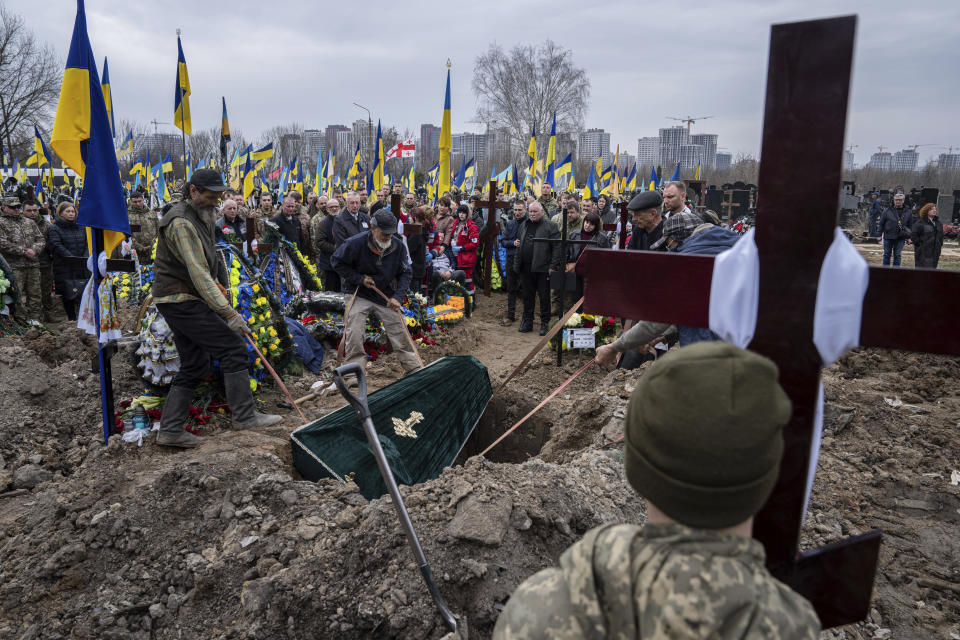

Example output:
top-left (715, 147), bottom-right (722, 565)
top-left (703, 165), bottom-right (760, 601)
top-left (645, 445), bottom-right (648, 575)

top-left (583, 16), bottom-right (960, 628)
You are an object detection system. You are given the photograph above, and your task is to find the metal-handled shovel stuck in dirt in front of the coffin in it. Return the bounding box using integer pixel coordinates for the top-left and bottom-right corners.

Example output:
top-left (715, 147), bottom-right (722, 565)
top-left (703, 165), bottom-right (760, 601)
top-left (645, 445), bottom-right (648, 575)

top-left (333, 362), bottom-right (467, 640)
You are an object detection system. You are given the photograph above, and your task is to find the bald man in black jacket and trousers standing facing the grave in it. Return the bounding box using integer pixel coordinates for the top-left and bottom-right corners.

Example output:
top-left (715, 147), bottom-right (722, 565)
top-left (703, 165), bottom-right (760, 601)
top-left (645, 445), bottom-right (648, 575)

top-left (513, 202), bottom-right (562, 336)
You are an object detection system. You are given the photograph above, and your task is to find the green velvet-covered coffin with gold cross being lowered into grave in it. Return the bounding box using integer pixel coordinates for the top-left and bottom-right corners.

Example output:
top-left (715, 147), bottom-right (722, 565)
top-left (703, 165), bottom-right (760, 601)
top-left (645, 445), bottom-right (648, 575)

top-left (290, 356), bottom-right (493, 499)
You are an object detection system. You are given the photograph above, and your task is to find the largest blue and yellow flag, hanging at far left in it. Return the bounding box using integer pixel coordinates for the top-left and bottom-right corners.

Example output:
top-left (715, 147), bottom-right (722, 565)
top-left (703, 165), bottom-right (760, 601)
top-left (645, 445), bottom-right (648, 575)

top-left (50, 0), bottom-right (130, 255)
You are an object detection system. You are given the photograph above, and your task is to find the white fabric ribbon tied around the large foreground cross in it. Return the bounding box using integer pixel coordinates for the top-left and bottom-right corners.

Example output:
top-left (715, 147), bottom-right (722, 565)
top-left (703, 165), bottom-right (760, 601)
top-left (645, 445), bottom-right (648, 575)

top-left (710, 227), bottom-right (870, 515)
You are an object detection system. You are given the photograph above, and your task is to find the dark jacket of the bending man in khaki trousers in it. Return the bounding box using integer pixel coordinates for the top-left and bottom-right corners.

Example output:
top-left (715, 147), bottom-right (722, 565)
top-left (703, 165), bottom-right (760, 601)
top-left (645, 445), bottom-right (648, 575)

top-left (330, 231), bottom-right (410, 305)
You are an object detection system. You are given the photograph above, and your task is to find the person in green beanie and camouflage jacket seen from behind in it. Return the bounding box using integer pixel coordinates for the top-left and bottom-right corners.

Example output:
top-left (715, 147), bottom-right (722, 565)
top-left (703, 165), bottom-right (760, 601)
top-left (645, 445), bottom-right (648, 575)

top-left (493, 342), bottom-right (820, 640)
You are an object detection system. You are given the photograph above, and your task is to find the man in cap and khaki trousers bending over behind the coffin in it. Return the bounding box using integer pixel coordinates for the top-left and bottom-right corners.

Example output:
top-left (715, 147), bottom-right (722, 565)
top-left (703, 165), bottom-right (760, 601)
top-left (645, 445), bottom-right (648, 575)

top-left (330, 209), bottom-right (420, 384)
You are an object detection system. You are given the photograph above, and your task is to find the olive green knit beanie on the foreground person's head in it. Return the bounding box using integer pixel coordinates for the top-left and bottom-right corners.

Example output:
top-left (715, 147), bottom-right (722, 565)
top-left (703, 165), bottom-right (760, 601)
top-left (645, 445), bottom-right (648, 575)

top-left (624, 342), bottom-right (791, 529)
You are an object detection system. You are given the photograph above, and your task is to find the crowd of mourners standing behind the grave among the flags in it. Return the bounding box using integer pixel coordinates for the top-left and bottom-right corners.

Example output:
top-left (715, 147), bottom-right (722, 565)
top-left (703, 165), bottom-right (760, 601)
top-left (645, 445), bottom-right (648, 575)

top-left (0, 175), bottom-right (944, 328)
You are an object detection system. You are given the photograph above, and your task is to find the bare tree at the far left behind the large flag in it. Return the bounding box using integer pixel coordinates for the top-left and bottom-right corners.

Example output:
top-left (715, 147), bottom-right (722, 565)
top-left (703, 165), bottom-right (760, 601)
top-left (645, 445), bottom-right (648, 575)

top-left (0, 4), bottom-right (63, 159)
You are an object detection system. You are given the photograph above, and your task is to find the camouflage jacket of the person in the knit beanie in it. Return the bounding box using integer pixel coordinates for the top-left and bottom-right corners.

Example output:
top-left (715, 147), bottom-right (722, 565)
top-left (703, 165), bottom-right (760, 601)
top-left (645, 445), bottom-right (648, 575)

top-left (493, 524), bottom-right (820, 640)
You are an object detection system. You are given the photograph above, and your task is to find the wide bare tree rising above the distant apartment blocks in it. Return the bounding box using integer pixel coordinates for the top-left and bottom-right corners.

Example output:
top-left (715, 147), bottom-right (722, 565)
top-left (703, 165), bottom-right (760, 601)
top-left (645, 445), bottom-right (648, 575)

top-left (472, 39), bottom-right (590, 154)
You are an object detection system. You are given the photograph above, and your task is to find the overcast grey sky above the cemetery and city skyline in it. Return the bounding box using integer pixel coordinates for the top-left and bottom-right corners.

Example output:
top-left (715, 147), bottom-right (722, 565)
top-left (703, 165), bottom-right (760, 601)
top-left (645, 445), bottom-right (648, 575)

top-left (6, 0), bottom-right (960, 164)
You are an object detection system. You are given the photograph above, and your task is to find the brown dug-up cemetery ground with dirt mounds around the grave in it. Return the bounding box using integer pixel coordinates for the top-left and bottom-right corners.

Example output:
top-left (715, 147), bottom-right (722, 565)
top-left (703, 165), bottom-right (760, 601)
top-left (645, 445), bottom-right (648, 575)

top-left (0, 243), bottom-right (960, 639)
